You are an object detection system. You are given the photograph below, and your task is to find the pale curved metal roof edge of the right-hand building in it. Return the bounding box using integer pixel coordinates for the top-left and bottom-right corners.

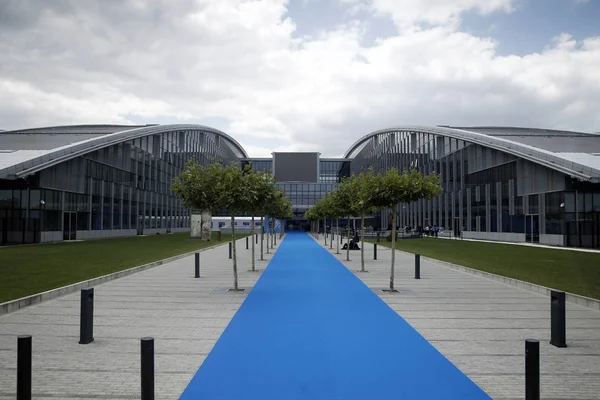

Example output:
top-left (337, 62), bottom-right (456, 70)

top-left (344, 126), bottom-right (600, 182)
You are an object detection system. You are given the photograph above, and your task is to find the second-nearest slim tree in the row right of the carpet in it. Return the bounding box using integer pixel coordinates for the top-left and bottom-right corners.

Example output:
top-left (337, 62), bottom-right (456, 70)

top-left (351, 168), bottom-right (378, 272)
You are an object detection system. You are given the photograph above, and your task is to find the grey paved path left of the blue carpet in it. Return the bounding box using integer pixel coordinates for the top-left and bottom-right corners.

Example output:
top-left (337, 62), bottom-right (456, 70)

top-left (0, 239), bottom-right (276, 400)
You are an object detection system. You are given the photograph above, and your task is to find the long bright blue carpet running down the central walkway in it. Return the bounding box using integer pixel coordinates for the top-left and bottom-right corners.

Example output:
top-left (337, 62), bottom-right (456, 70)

top-left (181, 234), bottom-right (490, 400)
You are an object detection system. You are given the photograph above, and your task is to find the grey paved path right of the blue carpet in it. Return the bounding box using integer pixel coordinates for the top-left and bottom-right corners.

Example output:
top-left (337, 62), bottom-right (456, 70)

top-left (319, 236), bottom-right (600, 400)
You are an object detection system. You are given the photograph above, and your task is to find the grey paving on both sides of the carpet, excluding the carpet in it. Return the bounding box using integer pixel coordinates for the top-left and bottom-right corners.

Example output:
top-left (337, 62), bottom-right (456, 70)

top-left (0, 233), bottom-right (600, 400)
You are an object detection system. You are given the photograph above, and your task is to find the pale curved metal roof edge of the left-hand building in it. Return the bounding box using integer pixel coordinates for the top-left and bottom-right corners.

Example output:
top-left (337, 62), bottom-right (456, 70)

top-left (0, 124), bottom-right (248, 177)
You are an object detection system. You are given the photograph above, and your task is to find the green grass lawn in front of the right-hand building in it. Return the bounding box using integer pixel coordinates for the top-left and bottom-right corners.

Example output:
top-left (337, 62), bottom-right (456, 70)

top-left (372, 238), bottom-right (600, 299)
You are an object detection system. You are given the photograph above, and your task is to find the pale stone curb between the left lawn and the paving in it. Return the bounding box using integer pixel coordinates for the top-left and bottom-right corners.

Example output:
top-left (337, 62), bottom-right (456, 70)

top-left (0, 238), bottom-right (239, 316)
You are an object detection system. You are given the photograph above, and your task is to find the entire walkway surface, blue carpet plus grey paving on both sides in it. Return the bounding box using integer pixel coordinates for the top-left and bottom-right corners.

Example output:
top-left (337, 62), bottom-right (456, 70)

top-left (0, 235), bottom-right (600, 400)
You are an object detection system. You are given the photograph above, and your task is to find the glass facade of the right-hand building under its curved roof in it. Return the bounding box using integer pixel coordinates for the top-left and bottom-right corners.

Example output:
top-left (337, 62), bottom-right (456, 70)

top-left (346, 130), bottom-right (600, 248)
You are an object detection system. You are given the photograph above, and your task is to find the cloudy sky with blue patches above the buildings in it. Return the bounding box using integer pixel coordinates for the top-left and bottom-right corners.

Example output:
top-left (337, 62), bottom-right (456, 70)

top-left (0, 0), bottom-right (600, 157)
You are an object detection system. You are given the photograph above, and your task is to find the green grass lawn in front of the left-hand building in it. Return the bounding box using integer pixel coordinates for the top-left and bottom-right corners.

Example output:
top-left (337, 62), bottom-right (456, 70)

top-left (0, 232), bottom-right (247, 303)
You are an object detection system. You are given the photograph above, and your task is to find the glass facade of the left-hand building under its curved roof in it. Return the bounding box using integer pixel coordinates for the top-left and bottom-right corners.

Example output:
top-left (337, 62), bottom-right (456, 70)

top-left (0, 128), bottom-right (245, 244)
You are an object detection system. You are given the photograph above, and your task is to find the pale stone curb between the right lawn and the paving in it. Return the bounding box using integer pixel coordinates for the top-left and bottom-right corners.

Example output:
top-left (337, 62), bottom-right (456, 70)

top-left (372, 241), bottom-right (600, 311)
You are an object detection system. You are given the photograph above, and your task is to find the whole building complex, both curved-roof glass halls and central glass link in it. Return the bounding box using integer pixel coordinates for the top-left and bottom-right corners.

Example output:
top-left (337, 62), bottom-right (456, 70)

top-left (0, 125), bottom-right (600, 248)
